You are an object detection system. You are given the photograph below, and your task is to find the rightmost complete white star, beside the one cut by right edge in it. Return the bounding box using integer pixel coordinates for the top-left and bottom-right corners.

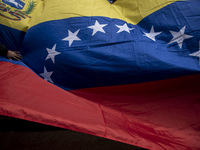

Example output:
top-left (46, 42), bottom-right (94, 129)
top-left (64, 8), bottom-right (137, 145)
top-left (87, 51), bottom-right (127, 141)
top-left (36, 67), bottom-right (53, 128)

top-left (168, 26), bottom-right (193, 48)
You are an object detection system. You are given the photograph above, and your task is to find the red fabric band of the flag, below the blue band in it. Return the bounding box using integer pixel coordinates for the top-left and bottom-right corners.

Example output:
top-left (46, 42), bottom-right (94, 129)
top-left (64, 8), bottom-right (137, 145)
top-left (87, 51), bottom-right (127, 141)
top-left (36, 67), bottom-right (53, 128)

top-left (0, 62), bottom-right (200, 150)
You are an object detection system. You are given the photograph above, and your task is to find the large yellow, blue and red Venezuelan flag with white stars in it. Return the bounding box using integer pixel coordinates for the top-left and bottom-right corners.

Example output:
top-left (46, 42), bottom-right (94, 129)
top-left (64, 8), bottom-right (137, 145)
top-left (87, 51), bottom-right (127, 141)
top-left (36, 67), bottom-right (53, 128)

top-left (0, 0), bottom-right (200, 150)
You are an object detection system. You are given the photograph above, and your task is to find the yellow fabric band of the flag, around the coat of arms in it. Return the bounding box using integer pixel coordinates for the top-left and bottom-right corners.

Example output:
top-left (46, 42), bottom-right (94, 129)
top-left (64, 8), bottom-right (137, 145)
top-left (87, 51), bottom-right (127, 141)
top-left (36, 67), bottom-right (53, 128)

top-left (0, 0), bottom-right (178, 31)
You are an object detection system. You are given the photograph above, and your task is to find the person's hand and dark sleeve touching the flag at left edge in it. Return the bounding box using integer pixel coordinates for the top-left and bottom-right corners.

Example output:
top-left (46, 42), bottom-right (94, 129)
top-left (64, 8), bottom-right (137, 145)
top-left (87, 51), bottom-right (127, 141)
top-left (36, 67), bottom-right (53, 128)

top-left (0, 43), bottom-right (22, 61)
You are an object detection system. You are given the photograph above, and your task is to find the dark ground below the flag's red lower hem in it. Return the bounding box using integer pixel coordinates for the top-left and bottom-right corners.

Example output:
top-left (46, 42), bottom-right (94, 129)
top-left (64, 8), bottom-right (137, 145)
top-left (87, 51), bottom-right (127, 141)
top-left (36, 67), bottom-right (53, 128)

top-left (0, 116), bottom-right (145, 150)
